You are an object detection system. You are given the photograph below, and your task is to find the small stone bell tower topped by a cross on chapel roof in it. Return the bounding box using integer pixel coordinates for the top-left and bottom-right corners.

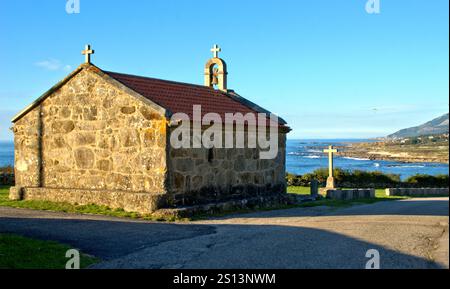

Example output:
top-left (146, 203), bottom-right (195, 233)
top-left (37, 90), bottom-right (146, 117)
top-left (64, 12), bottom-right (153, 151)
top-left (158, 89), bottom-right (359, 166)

top-left (205, 44), bottom-right (228, 92)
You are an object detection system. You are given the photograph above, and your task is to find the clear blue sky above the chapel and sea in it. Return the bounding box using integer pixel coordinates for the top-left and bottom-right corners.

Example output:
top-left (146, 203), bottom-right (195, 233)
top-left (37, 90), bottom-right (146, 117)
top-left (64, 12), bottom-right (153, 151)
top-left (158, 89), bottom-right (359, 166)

top-left (0, 0), bottom-right (449, 139)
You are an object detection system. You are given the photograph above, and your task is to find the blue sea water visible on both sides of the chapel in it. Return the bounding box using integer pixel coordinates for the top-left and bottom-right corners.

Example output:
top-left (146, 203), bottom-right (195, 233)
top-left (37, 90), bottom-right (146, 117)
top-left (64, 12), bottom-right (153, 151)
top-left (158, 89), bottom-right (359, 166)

top-left (0, 139), bottom-right (449, 179)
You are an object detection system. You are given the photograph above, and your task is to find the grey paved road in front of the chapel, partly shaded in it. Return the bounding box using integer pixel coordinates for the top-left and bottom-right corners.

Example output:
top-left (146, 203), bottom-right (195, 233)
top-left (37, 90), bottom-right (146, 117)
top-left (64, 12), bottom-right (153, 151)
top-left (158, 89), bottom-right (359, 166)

top-left (0, 198), bottom-right (449, 268)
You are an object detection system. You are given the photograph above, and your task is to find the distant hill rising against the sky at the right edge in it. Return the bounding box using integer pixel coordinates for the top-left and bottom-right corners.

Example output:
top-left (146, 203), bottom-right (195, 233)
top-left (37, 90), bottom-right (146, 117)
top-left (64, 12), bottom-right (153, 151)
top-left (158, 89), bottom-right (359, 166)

top-left (387, 113), bottom-right (449, 138)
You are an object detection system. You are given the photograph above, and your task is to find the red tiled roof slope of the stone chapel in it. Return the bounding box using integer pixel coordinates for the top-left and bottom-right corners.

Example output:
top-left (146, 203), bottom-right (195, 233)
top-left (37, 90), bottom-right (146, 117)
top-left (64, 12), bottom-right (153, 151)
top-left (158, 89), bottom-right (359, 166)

top-left (103, 71), bottom-right (283, 126)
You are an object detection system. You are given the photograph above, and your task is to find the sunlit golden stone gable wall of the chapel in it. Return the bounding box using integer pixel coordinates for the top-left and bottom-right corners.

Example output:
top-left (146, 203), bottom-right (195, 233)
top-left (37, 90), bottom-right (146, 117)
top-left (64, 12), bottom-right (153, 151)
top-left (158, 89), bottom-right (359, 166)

top-left (14, 69), bottom-right (166, 194)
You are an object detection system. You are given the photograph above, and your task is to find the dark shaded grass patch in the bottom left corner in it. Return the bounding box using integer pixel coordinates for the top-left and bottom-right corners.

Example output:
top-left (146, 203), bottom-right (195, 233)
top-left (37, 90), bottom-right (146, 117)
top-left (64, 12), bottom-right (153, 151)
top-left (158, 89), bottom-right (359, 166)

top-left (0, 234), bottom-right (99, 269)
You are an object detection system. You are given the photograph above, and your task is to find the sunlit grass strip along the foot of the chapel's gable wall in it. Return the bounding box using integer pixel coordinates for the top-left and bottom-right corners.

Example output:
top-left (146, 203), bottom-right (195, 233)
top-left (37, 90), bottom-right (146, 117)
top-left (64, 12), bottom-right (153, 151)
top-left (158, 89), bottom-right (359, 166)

top-left (0, 186), bottom-right (186, 222)
